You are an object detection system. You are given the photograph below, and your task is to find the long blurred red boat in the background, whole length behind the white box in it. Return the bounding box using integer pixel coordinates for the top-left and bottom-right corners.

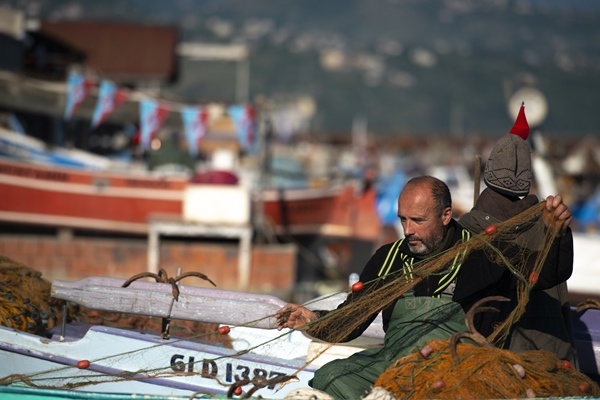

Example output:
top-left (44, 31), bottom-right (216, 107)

top-left (0, 130), bottom-right (380, 241)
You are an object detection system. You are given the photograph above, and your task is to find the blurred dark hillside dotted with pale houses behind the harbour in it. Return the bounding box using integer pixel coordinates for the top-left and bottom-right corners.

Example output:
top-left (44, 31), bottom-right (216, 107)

top-left (2, 0), bottom-right (600, 137)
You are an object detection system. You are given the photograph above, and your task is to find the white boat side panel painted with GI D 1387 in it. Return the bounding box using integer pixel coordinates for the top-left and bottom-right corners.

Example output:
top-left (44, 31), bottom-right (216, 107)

top-left (0, 326), bottom-right (314, 398)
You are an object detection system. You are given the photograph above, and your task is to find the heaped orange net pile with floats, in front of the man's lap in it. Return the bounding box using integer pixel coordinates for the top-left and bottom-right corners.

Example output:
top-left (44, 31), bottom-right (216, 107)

top-left (375, 340), bottom-right (600, 399)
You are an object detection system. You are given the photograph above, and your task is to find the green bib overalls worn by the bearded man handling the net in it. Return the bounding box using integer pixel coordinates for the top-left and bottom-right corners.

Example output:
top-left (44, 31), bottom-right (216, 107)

top-left (309, 239), bottom-right (467, 399)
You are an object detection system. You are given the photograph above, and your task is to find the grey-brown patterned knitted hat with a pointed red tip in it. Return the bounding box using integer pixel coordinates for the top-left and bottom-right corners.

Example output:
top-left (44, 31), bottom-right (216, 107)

top-left (483, 105), bottom-right (533, 196)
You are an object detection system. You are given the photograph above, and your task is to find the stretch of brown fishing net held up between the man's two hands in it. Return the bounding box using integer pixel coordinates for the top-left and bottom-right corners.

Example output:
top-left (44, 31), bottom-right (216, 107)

top-left (308, 202), bottom-right (564, 344)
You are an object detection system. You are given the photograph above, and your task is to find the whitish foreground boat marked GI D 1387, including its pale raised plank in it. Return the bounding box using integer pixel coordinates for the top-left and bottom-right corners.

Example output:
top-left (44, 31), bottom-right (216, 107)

top-left (0, 277), bottom-right (600, 399)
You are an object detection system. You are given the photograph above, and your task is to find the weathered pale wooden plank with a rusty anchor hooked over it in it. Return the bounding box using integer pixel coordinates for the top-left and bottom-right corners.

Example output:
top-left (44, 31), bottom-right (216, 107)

top-left (51, 277), bottom-right (286, 329)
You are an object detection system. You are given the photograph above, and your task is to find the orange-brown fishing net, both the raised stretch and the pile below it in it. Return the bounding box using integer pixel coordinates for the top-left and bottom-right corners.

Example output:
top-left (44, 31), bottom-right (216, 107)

top-left (308, 202), bottom-right (600, 399)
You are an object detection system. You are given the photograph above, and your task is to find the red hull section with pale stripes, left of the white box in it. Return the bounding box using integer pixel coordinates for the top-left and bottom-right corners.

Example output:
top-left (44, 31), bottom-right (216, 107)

top-left (0, 154), bottom-right (186, 233)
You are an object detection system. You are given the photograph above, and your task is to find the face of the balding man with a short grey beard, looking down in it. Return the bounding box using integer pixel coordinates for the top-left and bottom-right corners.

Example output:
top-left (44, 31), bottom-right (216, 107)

top-left (398, 185), bottom-right (452, 256)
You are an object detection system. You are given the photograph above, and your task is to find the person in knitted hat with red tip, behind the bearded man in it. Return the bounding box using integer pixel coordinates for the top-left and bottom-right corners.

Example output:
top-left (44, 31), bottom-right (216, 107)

top-left (459, 105), bottom-right (578, 367)
